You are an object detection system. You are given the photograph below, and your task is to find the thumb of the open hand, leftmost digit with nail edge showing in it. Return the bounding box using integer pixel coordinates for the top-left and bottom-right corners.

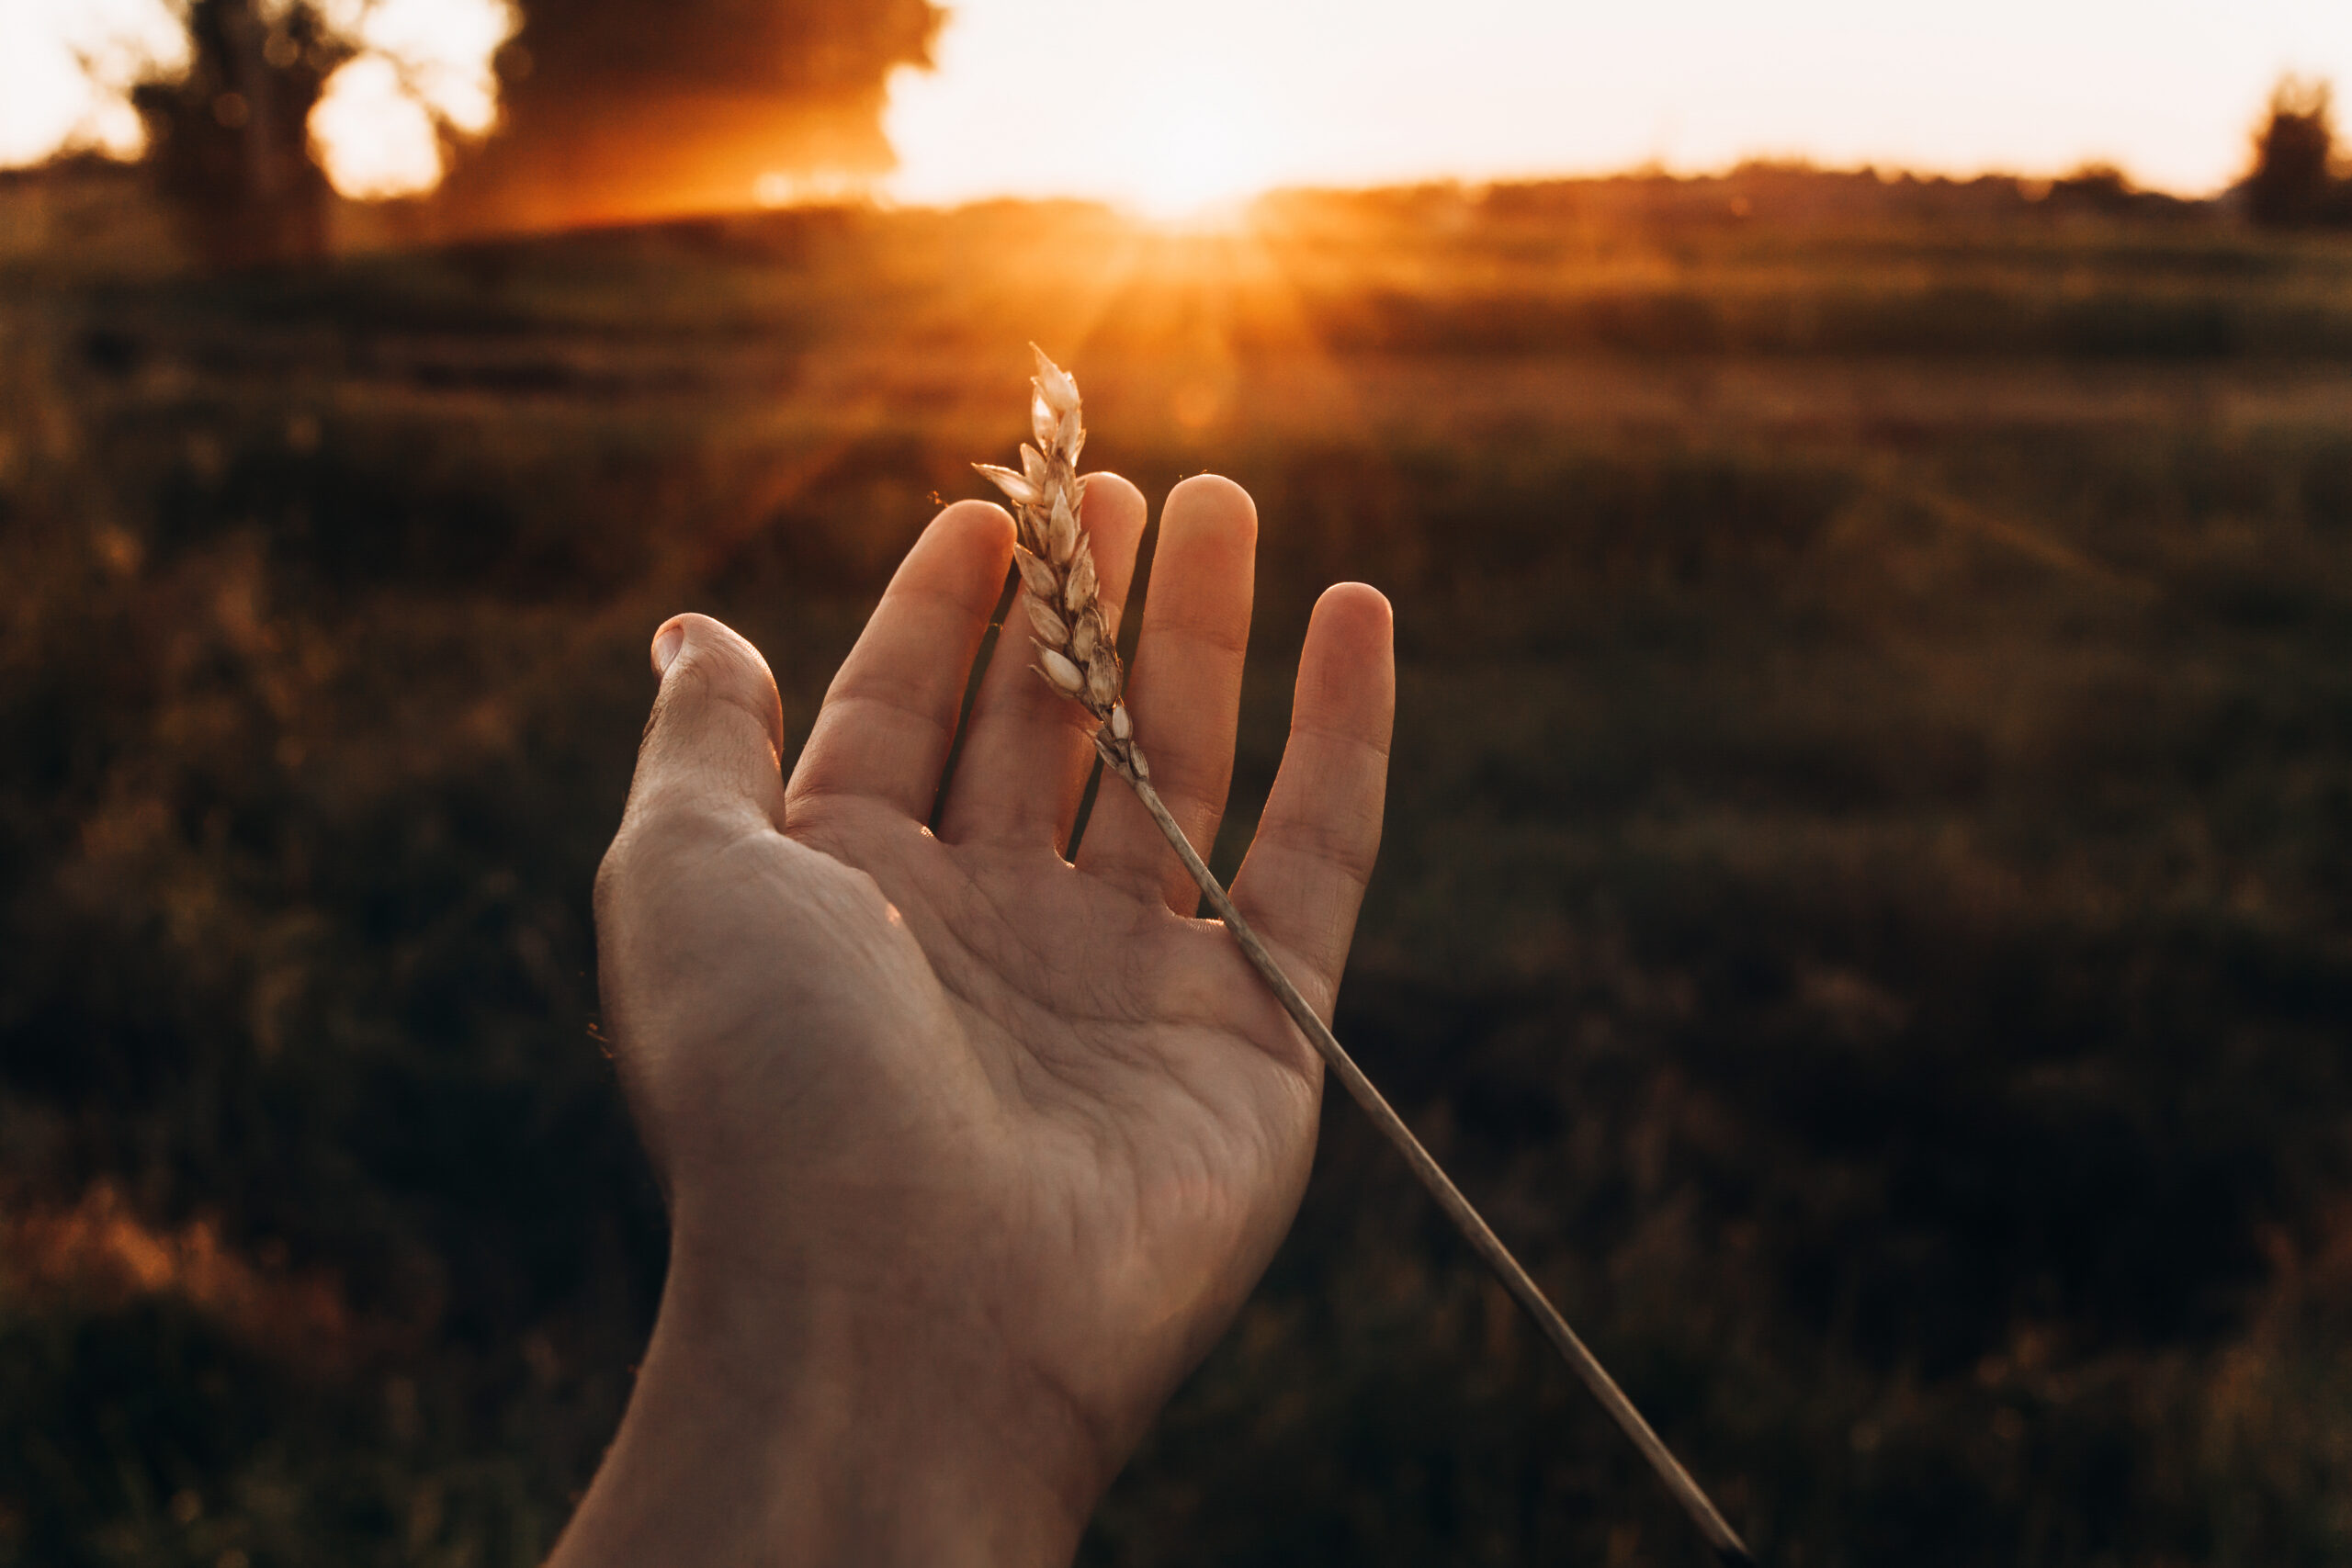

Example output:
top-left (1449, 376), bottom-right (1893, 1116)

top-left (623, 616), bottom-right (783, 832)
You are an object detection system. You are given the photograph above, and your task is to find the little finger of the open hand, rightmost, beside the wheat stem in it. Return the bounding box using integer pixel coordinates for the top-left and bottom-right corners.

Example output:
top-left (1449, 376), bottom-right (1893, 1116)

top-left (1232, 583), bottom-right (1397, 1021)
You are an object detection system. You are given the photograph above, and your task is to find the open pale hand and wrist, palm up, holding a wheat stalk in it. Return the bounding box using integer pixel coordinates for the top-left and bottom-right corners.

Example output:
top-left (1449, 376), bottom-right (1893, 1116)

top-left (553, 475), bottom-right (1395, 1568)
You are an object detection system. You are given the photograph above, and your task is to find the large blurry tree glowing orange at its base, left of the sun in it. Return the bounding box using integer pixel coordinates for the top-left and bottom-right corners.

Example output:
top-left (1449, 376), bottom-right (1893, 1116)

top-left (440, 0), bottom-right (944, 231)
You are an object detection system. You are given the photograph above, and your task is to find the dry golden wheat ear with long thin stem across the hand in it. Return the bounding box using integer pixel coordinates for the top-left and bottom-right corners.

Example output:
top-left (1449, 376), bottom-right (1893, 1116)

top-left (974, 344), bottom-right (1755, 1565)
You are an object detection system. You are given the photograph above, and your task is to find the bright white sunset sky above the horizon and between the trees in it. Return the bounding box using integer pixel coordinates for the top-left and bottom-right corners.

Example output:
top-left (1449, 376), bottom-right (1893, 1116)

top-left (14, 0), bottom-right (2352, 214)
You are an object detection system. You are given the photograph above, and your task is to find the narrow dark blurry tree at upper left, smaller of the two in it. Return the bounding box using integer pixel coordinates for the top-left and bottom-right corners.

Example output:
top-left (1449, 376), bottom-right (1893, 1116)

top-left (134, 0), bottom-right (348, 264)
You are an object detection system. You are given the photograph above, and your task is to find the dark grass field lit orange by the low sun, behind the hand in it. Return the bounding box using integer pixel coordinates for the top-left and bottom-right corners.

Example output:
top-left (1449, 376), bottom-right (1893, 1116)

top-left (0, 169), bottom-right (2352, 1568)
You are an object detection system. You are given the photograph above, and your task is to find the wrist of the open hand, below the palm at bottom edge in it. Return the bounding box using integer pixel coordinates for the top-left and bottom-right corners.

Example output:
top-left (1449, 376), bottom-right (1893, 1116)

top-left (550, 1232), bottom-right (1110, 1568)
